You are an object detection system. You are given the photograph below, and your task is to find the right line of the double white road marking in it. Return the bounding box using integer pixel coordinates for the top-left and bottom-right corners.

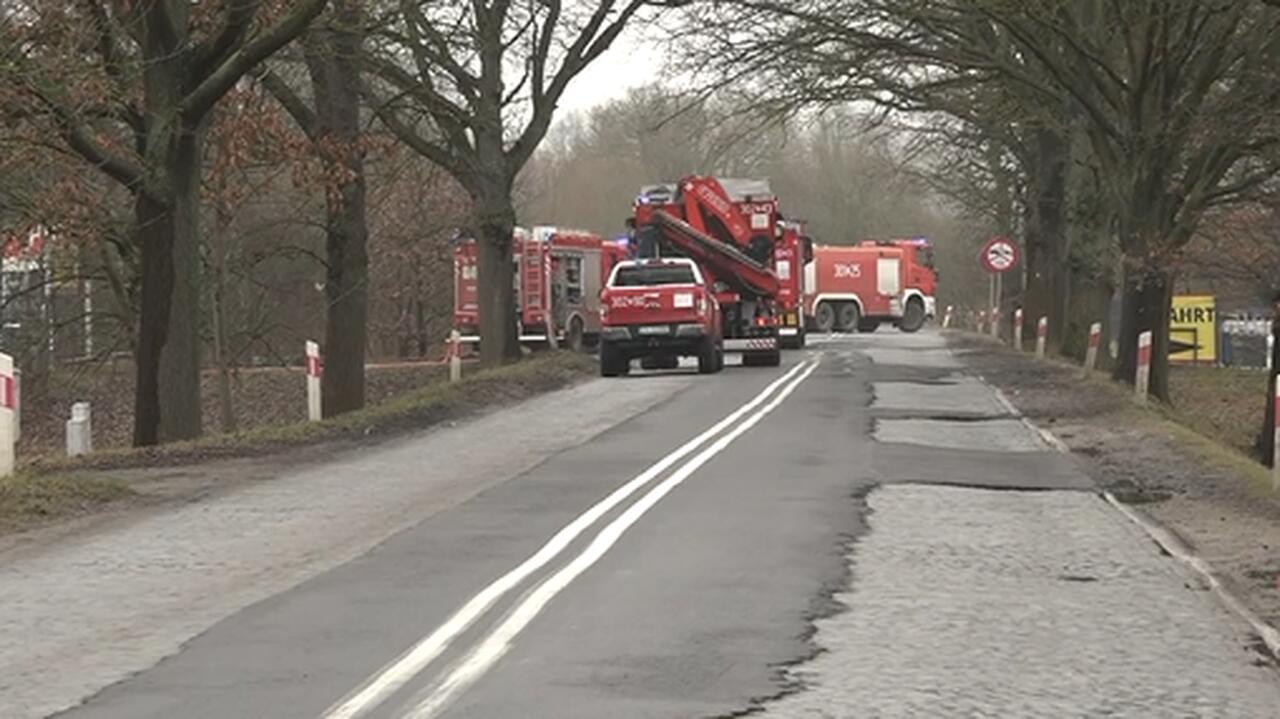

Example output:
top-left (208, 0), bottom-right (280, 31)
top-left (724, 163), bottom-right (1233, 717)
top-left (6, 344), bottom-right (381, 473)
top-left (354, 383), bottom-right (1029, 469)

top-left (404, 362), bottom-right (818, 719)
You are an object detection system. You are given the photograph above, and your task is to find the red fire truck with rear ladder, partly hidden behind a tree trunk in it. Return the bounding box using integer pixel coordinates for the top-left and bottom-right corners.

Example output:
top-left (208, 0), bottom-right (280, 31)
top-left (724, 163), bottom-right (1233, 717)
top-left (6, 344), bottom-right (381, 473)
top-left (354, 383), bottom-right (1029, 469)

top-left (453, 226), bottom-right (627, 351)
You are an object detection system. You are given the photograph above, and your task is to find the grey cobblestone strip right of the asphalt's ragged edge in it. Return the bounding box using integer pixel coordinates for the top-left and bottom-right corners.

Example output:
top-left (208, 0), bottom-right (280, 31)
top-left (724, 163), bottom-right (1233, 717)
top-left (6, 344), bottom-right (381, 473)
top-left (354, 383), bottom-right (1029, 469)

top-left (762, 332), bottom-right (1280, 716)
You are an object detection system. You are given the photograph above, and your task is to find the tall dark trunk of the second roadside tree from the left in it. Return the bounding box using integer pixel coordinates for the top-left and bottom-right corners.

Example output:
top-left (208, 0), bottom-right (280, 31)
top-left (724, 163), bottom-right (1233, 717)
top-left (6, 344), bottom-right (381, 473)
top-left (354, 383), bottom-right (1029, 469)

top-left (306, 0), bottom-right (369, 417)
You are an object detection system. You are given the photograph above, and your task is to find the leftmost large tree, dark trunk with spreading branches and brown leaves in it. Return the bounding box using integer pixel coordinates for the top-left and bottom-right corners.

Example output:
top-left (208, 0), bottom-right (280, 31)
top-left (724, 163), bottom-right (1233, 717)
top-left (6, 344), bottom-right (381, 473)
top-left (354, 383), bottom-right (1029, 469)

top-left (0, 0), bottom-right (326, 445)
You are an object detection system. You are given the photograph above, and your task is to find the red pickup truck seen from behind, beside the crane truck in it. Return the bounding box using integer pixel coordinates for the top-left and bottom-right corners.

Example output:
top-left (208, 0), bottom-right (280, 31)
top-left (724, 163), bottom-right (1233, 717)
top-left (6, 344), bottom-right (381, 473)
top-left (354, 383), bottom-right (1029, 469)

top-left (600, 258), bottom-right (724, 377)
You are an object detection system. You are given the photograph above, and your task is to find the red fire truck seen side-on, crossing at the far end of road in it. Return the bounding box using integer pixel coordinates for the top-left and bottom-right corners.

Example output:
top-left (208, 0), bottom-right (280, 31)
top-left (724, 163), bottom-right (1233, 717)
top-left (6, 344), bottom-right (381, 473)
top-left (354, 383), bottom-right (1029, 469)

top-left (805, 239), bottom-right (937, 333)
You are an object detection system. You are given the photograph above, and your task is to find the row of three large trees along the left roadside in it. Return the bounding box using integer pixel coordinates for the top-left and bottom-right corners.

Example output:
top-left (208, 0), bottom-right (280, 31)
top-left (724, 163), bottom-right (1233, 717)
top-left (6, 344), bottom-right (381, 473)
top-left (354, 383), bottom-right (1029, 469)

top-left (0, 0), bottom-right (680, 445)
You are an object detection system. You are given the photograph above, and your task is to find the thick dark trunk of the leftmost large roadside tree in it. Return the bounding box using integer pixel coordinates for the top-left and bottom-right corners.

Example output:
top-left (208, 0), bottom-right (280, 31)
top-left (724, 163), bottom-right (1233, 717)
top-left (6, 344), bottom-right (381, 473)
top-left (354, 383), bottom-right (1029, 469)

top-left (133, 128), bottom-right (201, 446)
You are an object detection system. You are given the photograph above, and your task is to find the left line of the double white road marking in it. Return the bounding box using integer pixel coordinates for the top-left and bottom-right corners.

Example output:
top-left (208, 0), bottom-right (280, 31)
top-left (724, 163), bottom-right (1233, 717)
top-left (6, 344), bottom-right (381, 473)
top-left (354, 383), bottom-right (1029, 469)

top-left (323, 363), bottom-right (805, 719)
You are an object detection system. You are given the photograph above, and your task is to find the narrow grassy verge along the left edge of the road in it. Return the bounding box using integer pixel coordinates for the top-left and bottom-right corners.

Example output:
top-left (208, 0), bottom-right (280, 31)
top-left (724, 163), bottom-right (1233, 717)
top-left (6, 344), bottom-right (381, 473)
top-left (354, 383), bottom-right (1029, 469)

top-left (26, 352), bottom-right (595, 473)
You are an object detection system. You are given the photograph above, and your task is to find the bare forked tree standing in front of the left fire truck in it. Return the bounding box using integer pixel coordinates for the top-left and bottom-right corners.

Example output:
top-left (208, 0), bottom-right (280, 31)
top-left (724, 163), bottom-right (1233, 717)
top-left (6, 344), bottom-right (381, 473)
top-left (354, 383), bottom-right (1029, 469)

top-left (355, 0), bottom-right (681, 365)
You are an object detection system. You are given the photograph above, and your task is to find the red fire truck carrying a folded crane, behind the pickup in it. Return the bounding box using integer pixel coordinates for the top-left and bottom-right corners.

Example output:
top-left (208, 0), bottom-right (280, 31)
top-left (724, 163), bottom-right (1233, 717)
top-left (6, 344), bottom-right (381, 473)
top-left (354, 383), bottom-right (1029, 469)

top-left (616, 175), bottom-right (810, 366)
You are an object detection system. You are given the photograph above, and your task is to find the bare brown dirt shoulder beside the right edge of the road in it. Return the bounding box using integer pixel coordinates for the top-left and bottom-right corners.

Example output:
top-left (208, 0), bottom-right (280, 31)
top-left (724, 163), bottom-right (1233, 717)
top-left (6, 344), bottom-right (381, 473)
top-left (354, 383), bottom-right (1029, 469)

top-left (947, 333), bottom-right (1280, 626)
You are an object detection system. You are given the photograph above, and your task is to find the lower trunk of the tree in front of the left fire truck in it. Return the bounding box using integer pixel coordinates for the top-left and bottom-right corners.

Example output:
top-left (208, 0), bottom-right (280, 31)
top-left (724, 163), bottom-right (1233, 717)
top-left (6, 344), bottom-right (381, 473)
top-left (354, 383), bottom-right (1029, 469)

top-left (476, 191), bottom-right (520, 367)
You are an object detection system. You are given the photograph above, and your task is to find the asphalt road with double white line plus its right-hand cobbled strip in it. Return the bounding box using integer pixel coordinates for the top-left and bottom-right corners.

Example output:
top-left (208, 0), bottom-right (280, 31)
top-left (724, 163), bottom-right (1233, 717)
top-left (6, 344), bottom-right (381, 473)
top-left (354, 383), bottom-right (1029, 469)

top-left (45, 330), bottom-right (1280, 719)
